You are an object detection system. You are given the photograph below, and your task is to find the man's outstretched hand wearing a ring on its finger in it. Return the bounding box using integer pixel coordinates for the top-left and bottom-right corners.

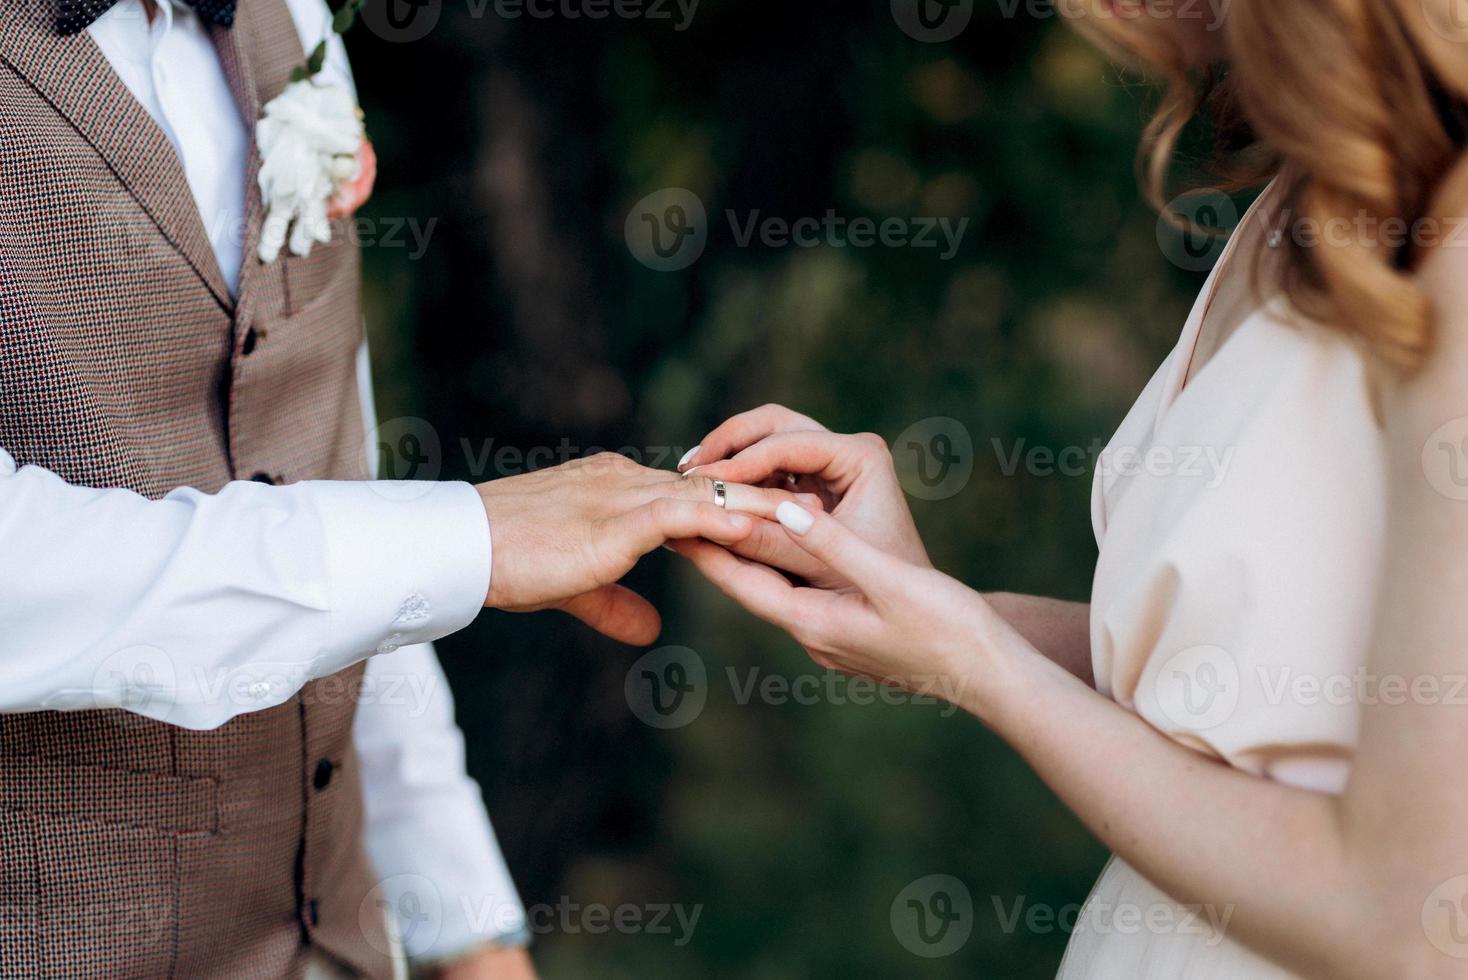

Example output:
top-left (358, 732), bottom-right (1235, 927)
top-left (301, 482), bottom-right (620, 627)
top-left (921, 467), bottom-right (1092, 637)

top-left (479, 453), bottom-right (819, 644)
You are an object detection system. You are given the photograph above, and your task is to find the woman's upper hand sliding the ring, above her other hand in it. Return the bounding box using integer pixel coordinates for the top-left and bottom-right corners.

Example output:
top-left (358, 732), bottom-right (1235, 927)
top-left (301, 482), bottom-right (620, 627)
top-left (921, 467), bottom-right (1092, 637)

top-left (686, 405), bottom-right (931, 588)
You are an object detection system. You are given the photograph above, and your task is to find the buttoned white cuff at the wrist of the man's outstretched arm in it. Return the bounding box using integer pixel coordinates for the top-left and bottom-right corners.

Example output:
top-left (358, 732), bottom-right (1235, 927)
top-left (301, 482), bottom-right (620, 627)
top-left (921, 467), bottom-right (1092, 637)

top-left (298, 480), bottom-right (492, 673)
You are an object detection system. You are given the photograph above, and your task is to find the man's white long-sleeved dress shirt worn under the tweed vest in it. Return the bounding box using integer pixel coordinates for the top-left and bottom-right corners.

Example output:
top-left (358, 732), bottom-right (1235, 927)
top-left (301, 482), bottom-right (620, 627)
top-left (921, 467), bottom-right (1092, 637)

top-left (0, 0), bottom-right (527, 959)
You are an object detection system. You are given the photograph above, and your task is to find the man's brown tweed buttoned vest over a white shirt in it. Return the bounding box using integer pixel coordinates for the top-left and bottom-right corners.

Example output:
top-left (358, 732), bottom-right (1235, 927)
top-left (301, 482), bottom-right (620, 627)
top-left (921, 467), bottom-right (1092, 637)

top-left (0, 0), bottom-right (389, 977)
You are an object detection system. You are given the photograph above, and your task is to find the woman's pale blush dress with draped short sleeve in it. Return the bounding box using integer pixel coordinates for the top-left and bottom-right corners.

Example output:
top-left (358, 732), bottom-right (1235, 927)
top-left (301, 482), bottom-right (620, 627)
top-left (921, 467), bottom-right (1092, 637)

top-left (1060, 189), bottom-right (1386, 980)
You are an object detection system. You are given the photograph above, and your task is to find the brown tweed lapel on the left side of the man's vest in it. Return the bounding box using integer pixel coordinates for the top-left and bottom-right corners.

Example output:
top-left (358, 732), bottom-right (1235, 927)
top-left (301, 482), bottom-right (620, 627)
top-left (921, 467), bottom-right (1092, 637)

top-left (0, 0), bottom-right (233, 310)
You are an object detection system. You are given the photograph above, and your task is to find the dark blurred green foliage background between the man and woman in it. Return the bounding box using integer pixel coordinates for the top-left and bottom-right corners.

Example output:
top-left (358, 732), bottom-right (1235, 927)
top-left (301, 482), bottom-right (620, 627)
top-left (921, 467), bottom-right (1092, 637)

top-left (349, 0), bottom-right (1198, 980)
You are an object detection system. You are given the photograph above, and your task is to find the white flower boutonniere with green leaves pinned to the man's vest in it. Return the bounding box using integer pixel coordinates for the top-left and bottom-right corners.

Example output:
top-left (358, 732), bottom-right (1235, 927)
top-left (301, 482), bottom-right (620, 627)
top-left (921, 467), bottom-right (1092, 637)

top-left (255, 0), bottom-right (367, 263)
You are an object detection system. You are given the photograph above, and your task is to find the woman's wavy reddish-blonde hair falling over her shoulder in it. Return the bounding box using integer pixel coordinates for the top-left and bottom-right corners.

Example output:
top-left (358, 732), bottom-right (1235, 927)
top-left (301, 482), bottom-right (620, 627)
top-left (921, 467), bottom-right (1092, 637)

top-left (1066, 0), bottom-right (1468, 374)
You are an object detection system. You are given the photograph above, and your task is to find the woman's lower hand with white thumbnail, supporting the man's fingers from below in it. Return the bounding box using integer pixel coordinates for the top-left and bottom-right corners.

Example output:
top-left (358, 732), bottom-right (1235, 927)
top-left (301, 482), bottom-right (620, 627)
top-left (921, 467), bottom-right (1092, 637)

top-left (674, 502), bottom-right (1004, 703)
